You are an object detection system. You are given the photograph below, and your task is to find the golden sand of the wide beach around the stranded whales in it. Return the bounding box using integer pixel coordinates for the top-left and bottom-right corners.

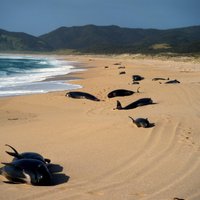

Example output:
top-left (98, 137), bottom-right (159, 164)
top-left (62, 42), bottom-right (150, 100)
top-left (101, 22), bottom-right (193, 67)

top-left (0, 56), bottom-right (200, 200)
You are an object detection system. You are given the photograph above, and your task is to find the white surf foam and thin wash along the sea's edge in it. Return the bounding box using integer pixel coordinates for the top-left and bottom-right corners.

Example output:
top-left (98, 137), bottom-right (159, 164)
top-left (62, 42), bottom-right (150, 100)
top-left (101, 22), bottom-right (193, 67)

top-left (0, 54), bottom-right (86, 98)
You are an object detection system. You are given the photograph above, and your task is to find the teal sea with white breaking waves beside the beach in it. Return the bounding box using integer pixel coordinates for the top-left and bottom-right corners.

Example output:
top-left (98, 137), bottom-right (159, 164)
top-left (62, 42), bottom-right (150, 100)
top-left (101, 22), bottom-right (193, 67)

top-left (0, 55), bottom-right (81, 97)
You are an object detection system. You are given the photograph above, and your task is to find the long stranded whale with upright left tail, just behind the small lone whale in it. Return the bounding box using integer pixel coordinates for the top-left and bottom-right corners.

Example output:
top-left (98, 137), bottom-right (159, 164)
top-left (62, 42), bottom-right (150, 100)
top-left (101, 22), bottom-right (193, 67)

top-left (116, 98), bottom-right (154, 110)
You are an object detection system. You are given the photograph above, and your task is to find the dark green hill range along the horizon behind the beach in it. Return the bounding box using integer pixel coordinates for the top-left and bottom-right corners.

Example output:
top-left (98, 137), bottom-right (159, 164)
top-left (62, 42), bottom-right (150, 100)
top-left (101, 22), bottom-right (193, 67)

top-left (0, 25), bottom-right (200, 53)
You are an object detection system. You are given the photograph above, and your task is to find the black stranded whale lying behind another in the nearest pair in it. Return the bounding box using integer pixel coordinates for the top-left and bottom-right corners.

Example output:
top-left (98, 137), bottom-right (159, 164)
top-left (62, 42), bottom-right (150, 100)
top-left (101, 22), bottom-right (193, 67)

top-left (6, 144), bottom-right (51, 164)
